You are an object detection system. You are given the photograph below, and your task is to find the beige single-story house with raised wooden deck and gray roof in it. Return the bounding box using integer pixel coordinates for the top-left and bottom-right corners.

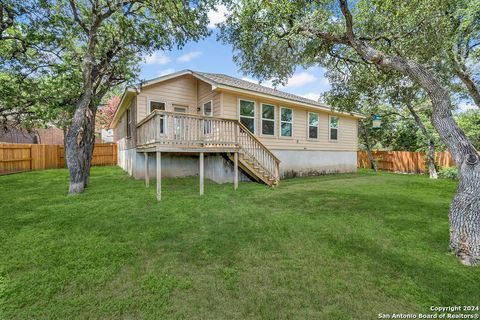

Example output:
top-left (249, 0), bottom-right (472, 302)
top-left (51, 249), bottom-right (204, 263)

top-left (111, 70), bottom-right (362, 198)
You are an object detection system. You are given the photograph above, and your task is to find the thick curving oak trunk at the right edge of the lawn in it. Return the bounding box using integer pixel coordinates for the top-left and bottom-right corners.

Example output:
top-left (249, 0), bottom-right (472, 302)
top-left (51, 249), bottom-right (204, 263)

top-left (339, 0), bottom-right (480, 265)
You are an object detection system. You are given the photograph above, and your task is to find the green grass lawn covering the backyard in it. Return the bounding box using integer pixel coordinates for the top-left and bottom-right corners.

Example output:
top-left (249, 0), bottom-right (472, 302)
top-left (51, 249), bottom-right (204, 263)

top-left (0, 167), bottom-right (480, 319)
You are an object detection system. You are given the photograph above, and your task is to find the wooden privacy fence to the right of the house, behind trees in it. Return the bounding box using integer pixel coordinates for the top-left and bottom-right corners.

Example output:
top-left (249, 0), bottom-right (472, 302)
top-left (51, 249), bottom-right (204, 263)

top-left (357, 151), bottom-right (455, 173)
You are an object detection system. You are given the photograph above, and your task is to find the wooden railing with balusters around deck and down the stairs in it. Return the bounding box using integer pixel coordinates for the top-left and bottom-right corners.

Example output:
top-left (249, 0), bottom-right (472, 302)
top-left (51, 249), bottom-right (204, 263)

top-left (137, 110), bottom-right (280, 179)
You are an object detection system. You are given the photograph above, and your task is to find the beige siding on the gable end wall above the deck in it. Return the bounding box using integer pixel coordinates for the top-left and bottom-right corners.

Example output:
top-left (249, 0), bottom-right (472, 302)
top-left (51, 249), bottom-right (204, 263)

top-left (137, 75), bottom-right (197, 122)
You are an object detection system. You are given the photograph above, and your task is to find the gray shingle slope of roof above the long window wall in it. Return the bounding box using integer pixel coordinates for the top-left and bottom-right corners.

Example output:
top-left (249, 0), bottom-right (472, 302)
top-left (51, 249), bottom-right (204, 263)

top-left (192, 71), bottom-right (330, 109)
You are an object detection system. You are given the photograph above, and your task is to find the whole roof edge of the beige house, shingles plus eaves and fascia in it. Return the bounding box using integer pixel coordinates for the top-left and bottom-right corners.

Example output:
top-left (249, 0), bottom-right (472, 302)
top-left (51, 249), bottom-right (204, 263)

top-left (111, 70), bottom-right (364, 127)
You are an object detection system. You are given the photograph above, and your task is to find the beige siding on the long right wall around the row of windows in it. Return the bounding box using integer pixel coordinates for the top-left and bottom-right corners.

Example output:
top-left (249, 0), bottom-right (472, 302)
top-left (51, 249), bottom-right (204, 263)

top-left (223, 92), bottom-right (357, 151)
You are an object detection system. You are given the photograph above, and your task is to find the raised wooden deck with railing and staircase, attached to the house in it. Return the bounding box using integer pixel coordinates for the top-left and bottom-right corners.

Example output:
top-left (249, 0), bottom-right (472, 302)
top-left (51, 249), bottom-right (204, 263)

top-left (136, 110), bottom-right (280, 199)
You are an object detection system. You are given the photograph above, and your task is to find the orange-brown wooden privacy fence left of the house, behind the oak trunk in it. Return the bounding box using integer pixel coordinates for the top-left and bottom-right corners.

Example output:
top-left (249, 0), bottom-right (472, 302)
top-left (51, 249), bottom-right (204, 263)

top-left (0, 143), bottom-right (117, 175)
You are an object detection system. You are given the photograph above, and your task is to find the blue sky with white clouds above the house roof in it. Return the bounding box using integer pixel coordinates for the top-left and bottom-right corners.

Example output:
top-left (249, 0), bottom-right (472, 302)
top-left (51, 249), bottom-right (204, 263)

top-left (140, 7), bottom-right (330, 100)
